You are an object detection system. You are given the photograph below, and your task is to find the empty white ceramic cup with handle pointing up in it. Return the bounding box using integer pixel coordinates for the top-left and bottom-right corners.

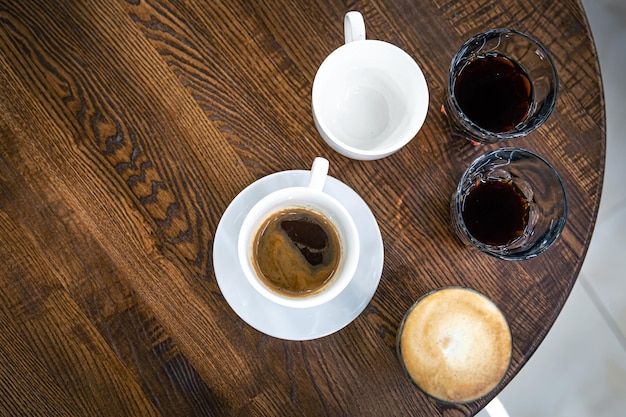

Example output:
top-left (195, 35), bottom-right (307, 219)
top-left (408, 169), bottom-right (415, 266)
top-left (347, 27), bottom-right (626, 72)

top-left (312, 11), bottom-right (428, 160)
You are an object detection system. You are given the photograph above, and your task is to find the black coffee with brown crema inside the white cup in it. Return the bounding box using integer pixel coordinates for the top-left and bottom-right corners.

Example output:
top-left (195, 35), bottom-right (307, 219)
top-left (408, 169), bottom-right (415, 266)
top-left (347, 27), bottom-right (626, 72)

top-left (252, 208), bottom-right (340, 297)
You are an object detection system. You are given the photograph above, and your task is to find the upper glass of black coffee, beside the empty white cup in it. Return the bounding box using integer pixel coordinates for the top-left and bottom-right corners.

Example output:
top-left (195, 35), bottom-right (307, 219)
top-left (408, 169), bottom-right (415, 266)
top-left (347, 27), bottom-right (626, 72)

top-left (442, 29), bottom-right (558, 143)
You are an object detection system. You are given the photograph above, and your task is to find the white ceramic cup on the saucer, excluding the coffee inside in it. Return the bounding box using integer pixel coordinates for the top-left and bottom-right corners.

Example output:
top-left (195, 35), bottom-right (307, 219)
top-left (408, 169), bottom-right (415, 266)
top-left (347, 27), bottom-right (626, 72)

top-left (237, 158), bottom-right (360, 308)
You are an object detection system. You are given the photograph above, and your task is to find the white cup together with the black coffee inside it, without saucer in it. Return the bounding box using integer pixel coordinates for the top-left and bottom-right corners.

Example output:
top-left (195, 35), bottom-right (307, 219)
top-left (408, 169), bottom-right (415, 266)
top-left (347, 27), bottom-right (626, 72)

top-left (238, 158), bottom-right (360, 308)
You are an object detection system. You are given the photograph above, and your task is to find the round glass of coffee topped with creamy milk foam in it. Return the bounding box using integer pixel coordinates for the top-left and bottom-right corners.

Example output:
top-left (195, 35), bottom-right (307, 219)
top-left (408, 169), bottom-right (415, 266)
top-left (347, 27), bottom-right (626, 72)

top-left (398, 288), bottom-right (512, 403)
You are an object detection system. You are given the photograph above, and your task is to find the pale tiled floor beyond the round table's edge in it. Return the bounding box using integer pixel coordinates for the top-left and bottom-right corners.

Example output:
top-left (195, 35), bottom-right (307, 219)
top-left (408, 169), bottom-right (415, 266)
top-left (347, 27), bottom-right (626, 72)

top-left (479, 0), bottom-right (626, 417)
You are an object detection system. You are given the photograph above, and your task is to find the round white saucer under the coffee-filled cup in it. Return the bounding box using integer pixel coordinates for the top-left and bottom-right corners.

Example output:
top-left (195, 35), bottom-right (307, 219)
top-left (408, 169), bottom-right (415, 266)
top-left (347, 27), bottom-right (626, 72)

top-left (213, 170), bottom-right (384, 340)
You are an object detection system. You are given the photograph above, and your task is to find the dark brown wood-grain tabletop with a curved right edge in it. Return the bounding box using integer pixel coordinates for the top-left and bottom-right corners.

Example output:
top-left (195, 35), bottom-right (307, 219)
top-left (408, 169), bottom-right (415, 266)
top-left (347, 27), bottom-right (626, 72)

top-left (0, 0), bottom-right (605, 417)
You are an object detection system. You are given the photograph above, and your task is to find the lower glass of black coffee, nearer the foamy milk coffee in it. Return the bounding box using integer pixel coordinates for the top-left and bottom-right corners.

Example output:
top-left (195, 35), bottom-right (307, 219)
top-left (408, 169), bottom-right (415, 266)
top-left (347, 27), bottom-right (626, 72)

top-left (451, 148), bottom-right (568, 261)
